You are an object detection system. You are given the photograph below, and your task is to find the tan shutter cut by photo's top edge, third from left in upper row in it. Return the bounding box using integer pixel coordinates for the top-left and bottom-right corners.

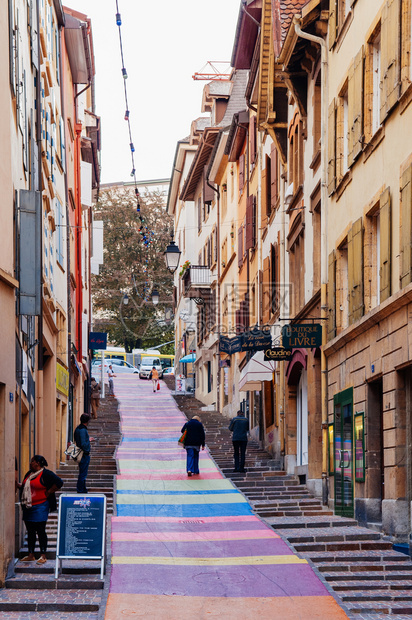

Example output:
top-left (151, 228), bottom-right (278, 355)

top-left (380, 0), bottom-right (401, 123)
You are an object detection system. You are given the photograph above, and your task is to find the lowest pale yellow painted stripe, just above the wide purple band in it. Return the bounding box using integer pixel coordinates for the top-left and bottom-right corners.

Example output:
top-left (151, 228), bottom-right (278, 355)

top-left (112, 555), bottom-right (307, 566)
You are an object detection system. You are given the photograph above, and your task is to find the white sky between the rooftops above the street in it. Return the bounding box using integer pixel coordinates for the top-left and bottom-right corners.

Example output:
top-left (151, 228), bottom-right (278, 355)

top-left (64, 0), bottom-right (240, 183)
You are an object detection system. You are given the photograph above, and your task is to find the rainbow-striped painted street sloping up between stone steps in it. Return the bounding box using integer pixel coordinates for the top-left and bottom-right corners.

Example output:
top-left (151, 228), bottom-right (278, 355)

top-left (105, 375), bottom-right (347, 620)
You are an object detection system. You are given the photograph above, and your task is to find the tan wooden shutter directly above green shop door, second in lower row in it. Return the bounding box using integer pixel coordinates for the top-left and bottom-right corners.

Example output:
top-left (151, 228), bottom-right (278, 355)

top-left (348, 217), bottom-right (363, 325)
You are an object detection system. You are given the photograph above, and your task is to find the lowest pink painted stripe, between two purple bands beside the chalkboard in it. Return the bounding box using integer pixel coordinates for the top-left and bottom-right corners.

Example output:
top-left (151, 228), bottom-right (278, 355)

top-left (112, 528), bottom-right (280, 542)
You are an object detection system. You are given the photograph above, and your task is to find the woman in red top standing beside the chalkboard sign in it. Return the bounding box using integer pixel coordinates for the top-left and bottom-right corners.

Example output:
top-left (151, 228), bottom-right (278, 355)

top-left (17, 454), bottom-right (63, 564)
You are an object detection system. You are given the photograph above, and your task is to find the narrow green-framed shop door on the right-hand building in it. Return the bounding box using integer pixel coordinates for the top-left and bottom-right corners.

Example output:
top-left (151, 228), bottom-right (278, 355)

top-left (333, 388), bottom-right (354, 517)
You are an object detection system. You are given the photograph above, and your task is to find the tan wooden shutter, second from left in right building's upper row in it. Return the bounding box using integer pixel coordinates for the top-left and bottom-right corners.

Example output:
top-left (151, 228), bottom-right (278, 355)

top-left (348, 46), bottom-right (364, 166)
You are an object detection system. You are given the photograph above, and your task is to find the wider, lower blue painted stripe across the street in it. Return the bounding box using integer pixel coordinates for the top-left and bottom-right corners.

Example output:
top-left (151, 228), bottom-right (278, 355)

top-left (117, 503), bottom-right (253, 519)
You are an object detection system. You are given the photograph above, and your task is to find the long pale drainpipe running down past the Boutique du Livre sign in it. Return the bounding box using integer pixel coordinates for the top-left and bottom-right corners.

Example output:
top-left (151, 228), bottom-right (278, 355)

top-left (293, 15), bottom-right (328, 505)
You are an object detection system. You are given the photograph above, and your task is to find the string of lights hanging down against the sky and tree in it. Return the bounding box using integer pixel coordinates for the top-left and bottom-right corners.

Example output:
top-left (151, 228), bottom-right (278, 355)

top-left (116, 0), bottom-right (154, 301)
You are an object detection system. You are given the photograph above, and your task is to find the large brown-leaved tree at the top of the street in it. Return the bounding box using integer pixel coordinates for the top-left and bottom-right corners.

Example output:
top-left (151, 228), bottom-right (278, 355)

top-left (92, 187), bottom-right (173, 352)
